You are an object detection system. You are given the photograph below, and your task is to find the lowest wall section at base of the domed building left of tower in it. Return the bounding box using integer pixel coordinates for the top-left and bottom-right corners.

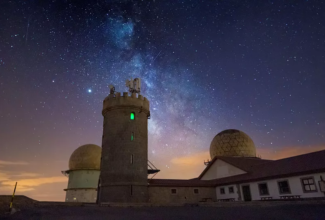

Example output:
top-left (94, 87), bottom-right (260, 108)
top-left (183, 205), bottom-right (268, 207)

top-left (65, 189), bottom-right (97, 203)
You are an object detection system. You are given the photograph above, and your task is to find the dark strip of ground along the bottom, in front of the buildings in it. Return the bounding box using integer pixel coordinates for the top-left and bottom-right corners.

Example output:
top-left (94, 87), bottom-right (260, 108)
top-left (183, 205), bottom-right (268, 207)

top-left (0, 199), bottom-right (325, 220)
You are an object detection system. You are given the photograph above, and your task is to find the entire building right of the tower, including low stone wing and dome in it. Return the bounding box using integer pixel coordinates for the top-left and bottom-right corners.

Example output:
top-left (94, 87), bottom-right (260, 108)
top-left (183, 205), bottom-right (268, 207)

top-left (149, 129), bottom-right (325, 203)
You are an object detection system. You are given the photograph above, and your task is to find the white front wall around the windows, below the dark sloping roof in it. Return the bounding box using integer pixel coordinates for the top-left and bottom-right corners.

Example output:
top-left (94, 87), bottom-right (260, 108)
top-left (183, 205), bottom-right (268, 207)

top-left (241, 173), bottom-right (325, 200)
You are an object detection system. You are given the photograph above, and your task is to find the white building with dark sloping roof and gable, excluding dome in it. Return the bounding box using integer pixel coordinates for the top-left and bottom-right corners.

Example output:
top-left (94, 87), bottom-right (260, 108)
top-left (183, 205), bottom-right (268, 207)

top-left (199, 150), bottom-right (325, 201)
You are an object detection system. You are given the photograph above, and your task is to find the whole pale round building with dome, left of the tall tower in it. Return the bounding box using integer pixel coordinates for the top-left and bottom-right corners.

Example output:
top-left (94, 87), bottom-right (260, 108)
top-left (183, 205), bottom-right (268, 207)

top-left (63, 144), bottom-right (101, 203)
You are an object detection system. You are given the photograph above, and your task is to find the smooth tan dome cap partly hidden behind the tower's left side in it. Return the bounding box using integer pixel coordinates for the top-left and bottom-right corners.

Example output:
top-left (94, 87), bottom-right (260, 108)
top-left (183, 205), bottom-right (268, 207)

top-left (69, 144), bottom-right (102, 170)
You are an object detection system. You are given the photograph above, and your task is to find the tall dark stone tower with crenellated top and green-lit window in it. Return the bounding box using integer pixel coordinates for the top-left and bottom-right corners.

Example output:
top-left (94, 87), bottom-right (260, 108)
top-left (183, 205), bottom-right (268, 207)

top-left (98, 92), bottom-right (150, 203)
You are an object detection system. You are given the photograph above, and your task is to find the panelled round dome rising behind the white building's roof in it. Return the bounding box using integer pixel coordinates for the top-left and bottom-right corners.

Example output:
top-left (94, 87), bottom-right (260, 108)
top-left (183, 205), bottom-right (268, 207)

top-left (210, 129), bottom-right (256, 159)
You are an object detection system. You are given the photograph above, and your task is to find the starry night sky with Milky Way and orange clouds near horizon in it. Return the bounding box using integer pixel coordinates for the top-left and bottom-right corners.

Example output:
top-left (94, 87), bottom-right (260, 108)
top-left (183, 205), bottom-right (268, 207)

top-left (0, 0), bottom-right (325, 201)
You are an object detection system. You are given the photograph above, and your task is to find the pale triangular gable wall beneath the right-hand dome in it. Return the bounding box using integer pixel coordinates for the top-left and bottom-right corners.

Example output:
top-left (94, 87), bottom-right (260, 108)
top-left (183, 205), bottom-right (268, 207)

top-left (201, 160), bottom-right (246, 180)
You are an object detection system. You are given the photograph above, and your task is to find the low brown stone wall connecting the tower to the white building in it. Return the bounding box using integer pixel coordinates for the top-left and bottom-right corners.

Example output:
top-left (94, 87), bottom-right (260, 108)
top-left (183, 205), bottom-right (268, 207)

top-left (149, 186), bottom-right (216, 204)
